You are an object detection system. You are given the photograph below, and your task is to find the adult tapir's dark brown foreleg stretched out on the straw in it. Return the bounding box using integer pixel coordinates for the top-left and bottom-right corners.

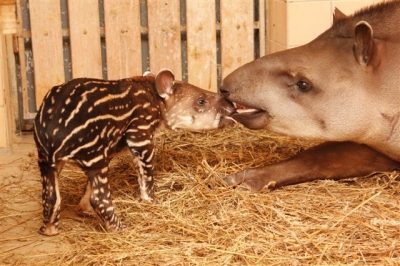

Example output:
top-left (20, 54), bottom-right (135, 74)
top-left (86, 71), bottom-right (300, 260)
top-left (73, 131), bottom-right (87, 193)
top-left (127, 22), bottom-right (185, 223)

top-left (224, 142), bottom-right (400, 191)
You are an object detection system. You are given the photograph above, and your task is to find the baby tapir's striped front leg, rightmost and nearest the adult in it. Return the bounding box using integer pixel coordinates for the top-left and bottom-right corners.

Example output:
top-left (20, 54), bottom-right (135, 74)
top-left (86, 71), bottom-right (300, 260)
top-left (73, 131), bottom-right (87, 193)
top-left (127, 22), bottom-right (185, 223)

top-left (126, 130), bottom-right (157, 203)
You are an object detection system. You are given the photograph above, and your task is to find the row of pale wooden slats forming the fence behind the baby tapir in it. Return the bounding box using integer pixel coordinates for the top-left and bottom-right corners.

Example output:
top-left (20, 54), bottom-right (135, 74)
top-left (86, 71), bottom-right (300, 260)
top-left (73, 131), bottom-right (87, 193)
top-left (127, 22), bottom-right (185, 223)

top-left (20, 0), bottom-right (265, 112)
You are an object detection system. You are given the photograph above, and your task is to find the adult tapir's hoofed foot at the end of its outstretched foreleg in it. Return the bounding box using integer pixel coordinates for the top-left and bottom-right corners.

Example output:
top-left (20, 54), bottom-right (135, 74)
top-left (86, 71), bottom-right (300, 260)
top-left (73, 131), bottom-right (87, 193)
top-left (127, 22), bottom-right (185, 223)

top-left (223, 169), bottom-right (274, 191)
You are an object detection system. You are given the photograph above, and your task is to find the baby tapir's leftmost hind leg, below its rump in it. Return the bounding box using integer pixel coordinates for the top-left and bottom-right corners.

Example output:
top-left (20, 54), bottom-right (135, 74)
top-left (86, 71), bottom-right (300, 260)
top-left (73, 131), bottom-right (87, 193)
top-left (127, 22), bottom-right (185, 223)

top-left (38, 159), bottom-right (64, 236)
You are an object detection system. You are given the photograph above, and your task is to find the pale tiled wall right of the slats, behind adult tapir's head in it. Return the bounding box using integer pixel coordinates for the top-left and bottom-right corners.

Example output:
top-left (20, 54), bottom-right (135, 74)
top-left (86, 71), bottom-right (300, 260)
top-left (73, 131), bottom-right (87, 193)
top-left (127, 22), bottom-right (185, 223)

top-left (267, 0), bottom-right (385, 53)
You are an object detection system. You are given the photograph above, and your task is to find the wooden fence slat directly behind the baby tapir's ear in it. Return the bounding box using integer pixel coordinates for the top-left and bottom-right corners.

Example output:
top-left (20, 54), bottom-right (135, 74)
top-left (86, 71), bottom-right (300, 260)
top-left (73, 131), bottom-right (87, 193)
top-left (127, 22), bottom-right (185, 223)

top-left (147, 0), bottom-right (182, 79)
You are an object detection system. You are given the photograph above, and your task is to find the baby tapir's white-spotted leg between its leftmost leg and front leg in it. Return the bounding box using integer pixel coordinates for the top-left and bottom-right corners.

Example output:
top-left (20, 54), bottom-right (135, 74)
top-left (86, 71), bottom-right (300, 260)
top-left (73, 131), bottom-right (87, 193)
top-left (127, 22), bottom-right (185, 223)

top-left (81, 166), bottom-right (123, 232)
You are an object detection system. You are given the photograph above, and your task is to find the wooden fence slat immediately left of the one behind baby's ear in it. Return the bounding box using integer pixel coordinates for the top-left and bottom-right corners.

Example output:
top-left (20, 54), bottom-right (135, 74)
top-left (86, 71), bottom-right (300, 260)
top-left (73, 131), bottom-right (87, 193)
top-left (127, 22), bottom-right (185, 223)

top-left (104, 0), bottom-right (142, 79)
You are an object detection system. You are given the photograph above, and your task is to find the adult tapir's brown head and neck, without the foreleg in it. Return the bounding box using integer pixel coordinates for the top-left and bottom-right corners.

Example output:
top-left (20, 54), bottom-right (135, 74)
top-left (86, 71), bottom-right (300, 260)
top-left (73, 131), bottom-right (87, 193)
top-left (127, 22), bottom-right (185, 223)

top-left (221, 1), bottom-right (400, 161)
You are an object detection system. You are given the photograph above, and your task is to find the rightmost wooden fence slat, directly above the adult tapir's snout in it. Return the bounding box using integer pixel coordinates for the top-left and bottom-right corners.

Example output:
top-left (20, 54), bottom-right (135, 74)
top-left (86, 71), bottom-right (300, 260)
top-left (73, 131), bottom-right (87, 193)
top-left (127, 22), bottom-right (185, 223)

top-left (221, 0), bottom-right (254, 78)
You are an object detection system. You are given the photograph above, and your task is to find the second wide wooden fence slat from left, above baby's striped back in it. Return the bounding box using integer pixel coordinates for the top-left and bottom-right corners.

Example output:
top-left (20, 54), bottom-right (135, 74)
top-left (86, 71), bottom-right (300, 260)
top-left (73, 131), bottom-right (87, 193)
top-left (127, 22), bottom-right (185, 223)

top-left (68, 0), bottom-right (103, 78)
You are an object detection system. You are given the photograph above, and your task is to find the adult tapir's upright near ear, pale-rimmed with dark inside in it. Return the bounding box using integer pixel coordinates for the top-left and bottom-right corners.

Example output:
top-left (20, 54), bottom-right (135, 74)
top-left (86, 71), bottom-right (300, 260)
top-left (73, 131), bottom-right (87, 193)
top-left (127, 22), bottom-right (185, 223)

top-left (354, 21), bottom-right (376, 67)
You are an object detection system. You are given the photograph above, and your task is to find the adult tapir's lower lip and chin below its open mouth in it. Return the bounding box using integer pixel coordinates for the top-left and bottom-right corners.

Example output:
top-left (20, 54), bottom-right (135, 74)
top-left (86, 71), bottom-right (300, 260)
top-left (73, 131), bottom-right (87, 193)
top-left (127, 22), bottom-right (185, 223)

top-left (232, 109), bottom-right (271, 129)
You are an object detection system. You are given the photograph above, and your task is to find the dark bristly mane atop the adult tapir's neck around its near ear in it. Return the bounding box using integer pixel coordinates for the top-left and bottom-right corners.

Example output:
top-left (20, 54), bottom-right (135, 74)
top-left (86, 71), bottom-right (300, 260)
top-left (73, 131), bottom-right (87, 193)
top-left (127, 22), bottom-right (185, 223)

top-left (322, 0), bottom-right (400, 41)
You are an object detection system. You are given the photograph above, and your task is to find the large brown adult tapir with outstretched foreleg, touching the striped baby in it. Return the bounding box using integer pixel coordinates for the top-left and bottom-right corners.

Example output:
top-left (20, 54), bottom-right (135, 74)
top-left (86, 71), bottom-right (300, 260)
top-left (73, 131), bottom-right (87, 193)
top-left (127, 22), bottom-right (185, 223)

top-left (221, 1), bottom-right (400, 191)
